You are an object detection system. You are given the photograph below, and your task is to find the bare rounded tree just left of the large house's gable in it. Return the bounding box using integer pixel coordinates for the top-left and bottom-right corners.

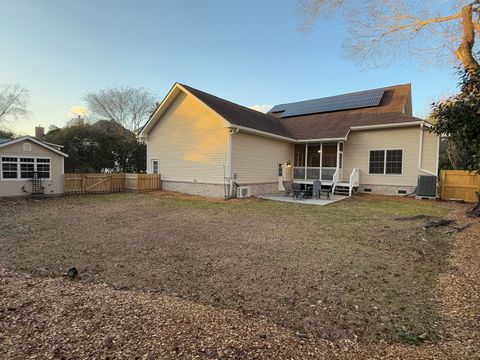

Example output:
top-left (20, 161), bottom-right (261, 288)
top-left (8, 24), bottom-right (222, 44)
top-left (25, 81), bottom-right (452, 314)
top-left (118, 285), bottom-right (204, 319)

top-left (84, 87), bottom-right (155, 133)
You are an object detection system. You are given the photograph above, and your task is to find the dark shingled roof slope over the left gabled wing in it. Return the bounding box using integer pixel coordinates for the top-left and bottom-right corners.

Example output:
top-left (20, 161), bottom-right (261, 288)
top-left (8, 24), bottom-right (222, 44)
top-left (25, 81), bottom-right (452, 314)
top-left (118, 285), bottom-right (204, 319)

top-left (180, 84), bottom-right (292, 138)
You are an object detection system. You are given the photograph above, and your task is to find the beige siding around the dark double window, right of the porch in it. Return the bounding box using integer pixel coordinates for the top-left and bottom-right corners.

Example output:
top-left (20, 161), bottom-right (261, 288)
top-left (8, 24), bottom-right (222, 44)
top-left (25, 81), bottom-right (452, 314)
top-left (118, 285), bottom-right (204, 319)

top-left (343, 126), bottom-right (436, 186)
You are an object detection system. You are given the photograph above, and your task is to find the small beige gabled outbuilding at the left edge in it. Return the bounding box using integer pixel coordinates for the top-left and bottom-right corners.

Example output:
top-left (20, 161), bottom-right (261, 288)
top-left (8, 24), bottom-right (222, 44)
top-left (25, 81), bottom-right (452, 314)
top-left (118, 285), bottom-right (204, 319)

top-left (0, 128), bottom-right (68, 197)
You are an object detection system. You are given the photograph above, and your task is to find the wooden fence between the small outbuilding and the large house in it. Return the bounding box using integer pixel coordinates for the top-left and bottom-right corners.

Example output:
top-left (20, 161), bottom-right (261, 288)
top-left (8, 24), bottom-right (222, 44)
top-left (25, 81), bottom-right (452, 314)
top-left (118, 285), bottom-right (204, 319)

top-left (63, 173), bottom-right (162, 195)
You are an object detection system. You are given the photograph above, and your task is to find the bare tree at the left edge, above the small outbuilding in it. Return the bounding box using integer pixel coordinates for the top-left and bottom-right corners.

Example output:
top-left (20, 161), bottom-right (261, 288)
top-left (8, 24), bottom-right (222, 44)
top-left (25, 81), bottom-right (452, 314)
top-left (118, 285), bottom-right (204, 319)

top-left (0, 85), bottom-right (28, 123)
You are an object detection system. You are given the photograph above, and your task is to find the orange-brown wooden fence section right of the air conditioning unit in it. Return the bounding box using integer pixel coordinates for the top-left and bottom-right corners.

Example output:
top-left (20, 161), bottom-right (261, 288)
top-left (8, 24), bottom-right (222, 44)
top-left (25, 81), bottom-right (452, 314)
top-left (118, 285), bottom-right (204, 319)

top-left (440, 170), bottom-right (480, 202)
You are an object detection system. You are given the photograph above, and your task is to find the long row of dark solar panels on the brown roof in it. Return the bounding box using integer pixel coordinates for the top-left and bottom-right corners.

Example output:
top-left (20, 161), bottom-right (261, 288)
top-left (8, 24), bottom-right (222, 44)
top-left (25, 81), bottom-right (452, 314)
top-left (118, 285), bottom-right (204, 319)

top-left (269, 89), bottom-right (385, 117)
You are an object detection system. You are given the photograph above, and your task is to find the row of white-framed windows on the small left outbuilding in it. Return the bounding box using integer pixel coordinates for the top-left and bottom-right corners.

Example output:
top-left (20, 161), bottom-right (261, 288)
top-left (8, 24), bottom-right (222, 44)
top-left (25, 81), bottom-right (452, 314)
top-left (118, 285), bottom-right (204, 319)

top-left (0, 156), bottom-right (51, 180)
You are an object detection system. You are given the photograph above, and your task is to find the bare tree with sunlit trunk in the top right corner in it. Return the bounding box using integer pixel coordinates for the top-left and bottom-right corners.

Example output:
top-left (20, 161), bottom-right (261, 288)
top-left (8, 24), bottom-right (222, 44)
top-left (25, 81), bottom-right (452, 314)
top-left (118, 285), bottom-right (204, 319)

top-left (298, 0), bottom-right (480, 71)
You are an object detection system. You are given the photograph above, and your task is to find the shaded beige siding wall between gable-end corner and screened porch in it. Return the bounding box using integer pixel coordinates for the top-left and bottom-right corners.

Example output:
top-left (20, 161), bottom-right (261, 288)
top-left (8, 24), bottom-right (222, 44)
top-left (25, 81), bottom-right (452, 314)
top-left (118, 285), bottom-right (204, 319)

top-left (232, 132), bottom-right (293, 184)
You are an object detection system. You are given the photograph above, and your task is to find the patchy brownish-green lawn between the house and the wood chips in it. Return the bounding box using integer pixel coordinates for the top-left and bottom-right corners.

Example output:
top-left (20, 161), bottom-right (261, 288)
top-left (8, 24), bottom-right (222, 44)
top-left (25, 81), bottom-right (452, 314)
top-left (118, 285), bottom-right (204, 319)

top-left (0, 193), bottom-right (450, 342)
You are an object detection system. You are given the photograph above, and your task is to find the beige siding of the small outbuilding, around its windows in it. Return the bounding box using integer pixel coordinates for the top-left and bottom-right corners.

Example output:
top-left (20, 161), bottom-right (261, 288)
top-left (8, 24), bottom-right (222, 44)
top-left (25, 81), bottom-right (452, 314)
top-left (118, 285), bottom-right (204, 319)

top-left (0, 140), bottom-right (63, 197)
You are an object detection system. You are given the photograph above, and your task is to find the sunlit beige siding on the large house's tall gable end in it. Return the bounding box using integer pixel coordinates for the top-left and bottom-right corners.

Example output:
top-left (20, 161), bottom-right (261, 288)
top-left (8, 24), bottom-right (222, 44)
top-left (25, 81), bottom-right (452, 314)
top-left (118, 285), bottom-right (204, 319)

top-left (147, 92), bottom-right (228, 184)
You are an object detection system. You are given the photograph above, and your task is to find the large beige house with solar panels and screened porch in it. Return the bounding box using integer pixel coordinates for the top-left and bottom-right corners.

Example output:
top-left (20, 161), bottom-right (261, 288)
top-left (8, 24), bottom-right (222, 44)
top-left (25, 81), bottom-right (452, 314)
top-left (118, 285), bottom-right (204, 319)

top-left (140, 83), bottom-right (439, 197)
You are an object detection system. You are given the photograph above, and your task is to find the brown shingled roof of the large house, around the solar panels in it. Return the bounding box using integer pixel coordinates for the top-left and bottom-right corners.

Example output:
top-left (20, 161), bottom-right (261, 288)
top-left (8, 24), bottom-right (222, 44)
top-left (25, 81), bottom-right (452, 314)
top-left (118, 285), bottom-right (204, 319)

top-left (141, 83), bottom-right (424, 141)
